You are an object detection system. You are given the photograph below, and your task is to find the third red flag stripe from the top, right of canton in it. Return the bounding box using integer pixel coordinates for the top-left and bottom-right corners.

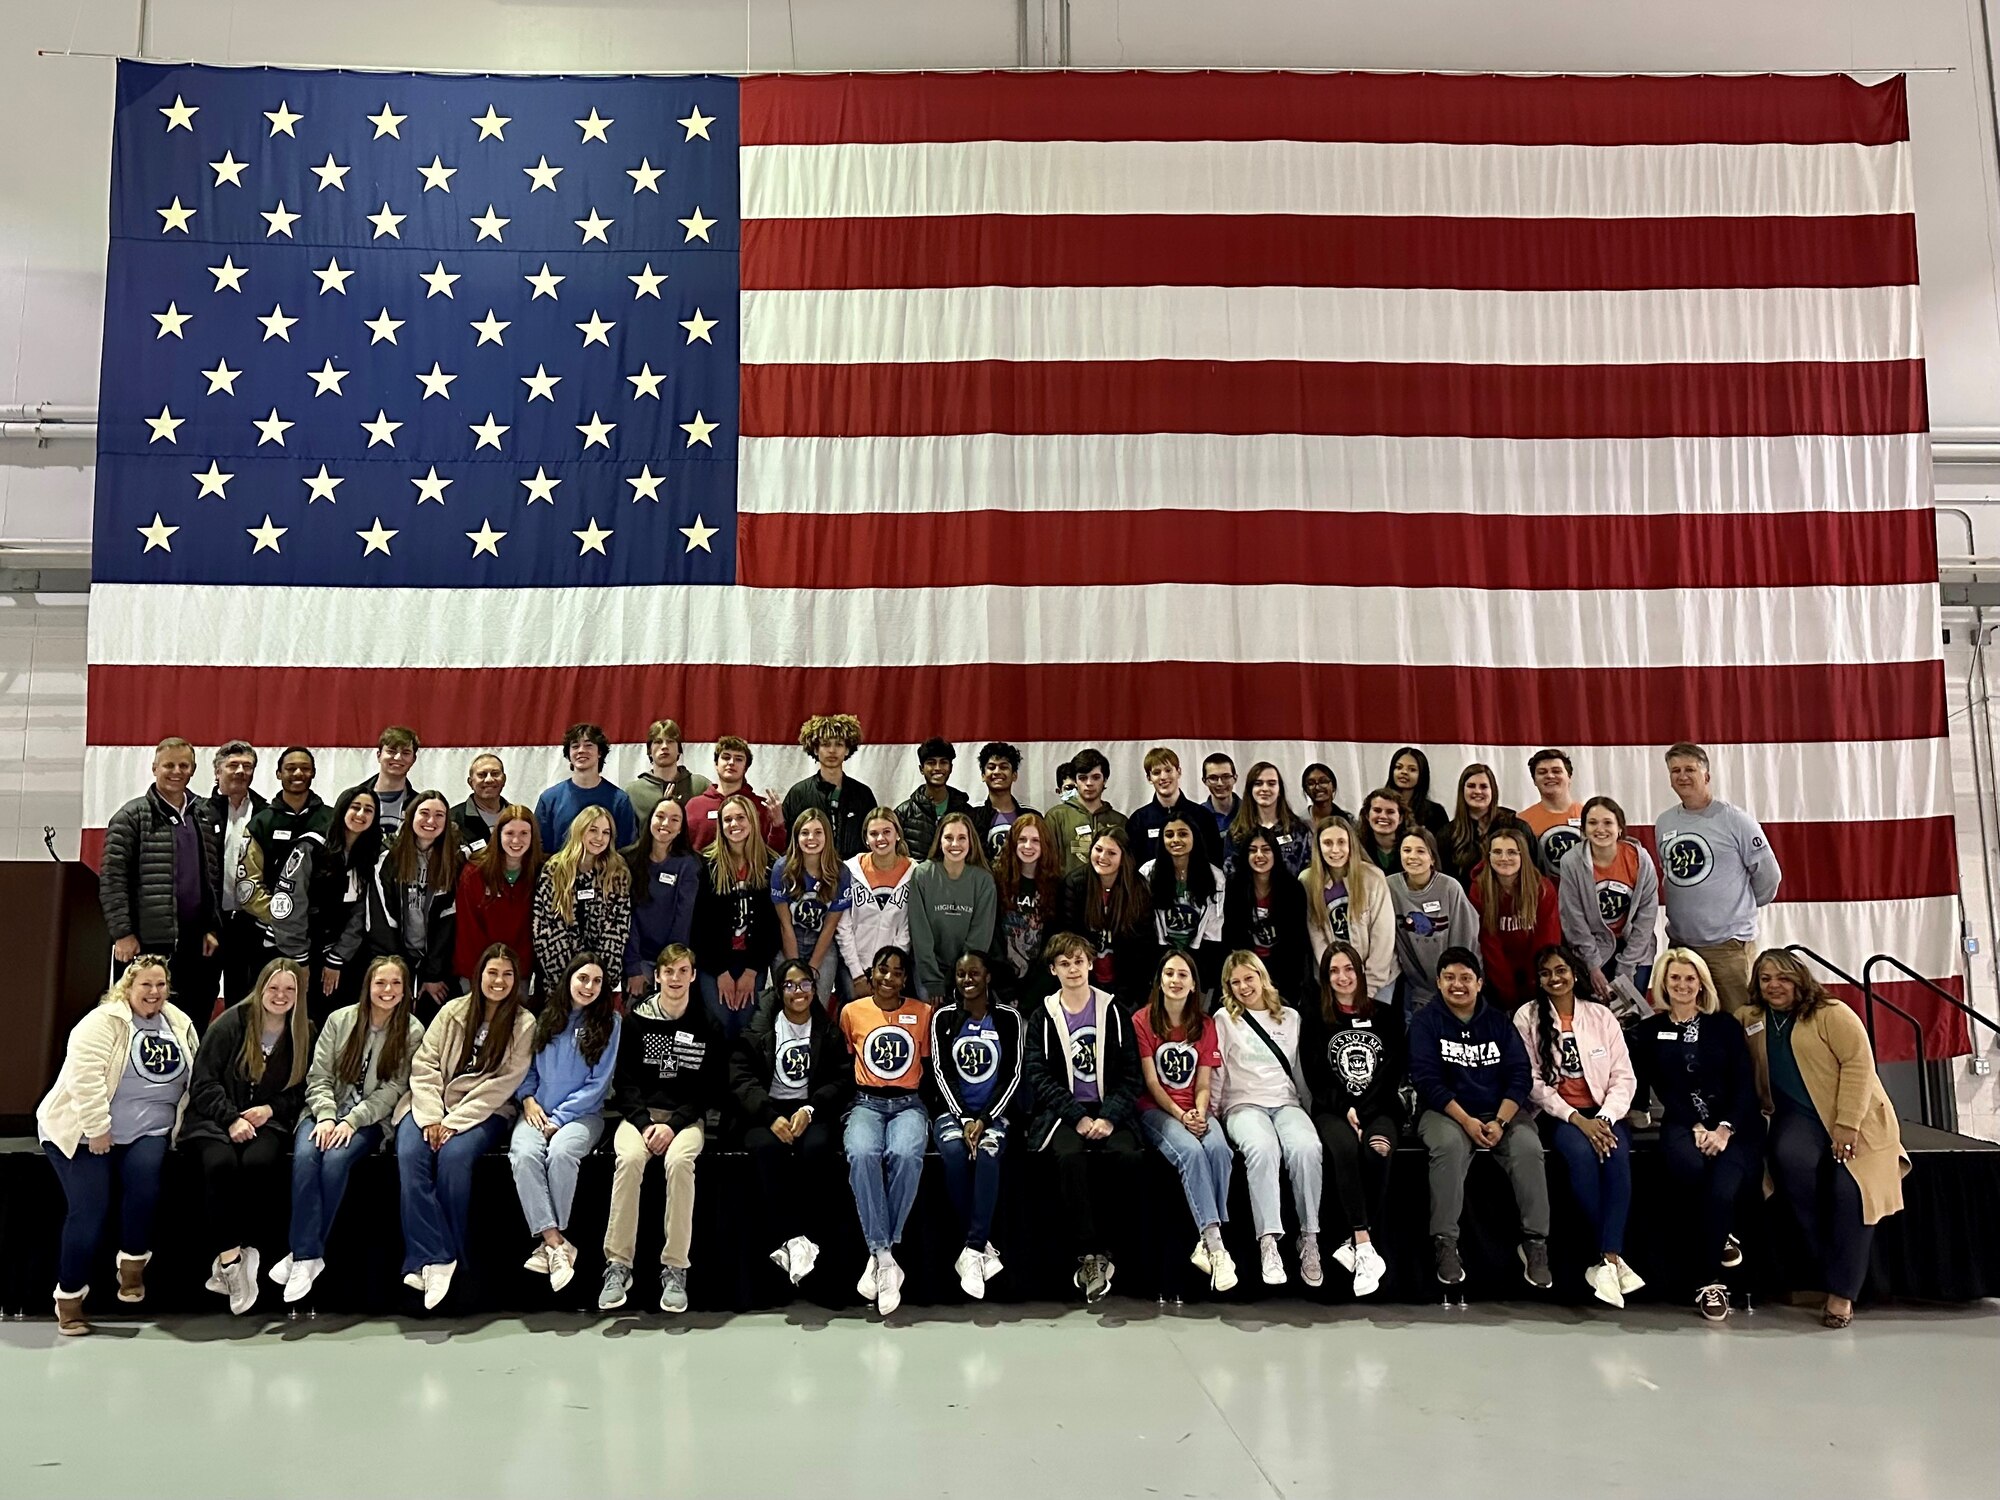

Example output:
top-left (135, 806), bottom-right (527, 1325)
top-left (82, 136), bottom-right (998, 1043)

top-left (742, 360), bottom-right (1928, 438)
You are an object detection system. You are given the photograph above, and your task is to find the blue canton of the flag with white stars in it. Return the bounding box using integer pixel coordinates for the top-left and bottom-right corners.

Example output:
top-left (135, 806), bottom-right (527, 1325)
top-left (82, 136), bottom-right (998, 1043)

top-left (92, 64), bottom-right (740, 588)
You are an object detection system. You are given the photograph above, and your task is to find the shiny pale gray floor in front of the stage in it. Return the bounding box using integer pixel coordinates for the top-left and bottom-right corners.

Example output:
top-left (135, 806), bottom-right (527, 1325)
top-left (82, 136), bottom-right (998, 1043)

top-left (0, 1298), bottom-right (2000, 1500)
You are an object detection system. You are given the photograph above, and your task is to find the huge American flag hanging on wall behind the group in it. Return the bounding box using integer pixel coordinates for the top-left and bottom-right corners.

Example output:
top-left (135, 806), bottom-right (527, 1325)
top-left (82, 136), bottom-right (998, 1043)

top-left (86, 64), bottom-right (1960, 1052)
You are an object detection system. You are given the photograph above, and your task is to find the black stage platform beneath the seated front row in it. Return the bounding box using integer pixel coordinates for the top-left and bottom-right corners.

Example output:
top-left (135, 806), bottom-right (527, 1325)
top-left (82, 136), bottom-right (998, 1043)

top-left (0, 1122), bottom-right (2000, 1316)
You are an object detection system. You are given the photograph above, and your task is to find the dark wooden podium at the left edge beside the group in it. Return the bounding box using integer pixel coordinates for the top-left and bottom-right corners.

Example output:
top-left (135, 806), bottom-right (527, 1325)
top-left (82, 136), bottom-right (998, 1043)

top-left (0, 860), bottom-right (112, 1130)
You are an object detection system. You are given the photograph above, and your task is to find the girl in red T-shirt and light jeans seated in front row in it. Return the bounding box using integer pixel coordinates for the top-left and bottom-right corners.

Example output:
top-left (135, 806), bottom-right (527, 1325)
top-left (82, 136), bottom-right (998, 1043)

top-left (1132, 950), bottom-right (1236, 1292)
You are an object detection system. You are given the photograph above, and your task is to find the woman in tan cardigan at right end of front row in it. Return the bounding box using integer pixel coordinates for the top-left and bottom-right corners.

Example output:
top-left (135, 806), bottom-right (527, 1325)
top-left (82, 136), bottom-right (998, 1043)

top-left (1744, 948), bottom-right (1910, 1328)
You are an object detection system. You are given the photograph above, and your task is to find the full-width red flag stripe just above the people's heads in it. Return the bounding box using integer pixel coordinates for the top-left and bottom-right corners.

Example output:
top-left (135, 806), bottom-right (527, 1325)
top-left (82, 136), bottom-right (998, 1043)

top-left (86, 664), bottom-right (1944, 744)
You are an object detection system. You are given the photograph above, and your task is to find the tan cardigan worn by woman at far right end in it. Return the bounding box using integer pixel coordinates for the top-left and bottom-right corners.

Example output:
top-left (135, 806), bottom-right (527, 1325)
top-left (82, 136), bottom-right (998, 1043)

top-left (1736, 1000), bottom-right (1910, 1224)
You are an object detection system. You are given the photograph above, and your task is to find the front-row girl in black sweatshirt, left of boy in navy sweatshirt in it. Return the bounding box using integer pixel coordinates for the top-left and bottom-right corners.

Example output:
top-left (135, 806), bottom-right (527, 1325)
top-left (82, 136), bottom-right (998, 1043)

top-left (1298, 938), bottom-right (1404, 1296)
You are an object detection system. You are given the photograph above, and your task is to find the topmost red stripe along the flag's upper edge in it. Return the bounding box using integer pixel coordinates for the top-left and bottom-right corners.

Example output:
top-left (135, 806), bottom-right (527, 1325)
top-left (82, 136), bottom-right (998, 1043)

top-left (740, 72), bottom-right (1910, 146)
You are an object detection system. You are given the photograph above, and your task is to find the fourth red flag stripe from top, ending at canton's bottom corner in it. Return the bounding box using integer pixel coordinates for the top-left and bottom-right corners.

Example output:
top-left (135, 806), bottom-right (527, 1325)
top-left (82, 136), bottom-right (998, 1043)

top-left (736, 510), bottom-right (1938, 590)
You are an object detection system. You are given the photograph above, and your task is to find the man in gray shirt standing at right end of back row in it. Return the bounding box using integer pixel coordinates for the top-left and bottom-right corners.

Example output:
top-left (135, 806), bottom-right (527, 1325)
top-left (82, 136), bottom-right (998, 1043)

top-left (1652, 740), bottom-right (1784, 1014)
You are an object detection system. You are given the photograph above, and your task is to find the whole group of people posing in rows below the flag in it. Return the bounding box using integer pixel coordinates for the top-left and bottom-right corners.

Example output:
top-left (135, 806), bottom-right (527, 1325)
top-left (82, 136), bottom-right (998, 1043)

top-left (38, 714), bottom-right (1908, 1332)
